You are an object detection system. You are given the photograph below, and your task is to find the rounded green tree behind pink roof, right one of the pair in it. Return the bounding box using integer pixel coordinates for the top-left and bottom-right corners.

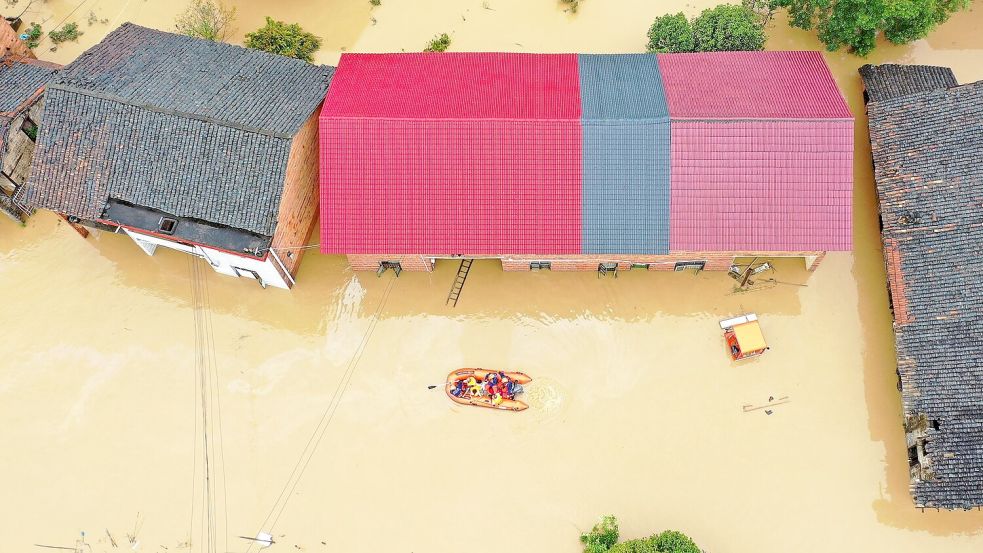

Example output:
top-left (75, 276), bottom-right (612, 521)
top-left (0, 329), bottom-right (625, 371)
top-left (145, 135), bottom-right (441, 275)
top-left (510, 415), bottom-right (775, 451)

top-left (693, 0), bottom-right (768, 52)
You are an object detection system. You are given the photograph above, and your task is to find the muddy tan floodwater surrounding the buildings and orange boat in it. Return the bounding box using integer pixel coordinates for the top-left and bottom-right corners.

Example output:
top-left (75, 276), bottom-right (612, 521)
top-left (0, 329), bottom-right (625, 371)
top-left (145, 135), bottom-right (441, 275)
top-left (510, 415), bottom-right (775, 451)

top-left (0, 0), bottom-right (983, 553)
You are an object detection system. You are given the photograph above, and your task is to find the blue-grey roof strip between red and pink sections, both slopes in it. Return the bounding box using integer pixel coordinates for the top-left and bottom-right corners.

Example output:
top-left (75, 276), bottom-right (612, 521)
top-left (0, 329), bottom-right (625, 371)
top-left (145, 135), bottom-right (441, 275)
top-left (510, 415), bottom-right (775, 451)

top-left (577, 54), bottom-right (670, 254)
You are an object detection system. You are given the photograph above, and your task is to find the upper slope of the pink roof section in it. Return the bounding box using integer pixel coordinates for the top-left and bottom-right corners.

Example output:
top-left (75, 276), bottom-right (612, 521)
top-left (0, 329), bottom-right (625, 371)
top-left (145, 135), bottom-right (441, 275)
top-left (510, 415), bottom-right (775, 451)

top-left (658, 51), bottom-right (853, 119)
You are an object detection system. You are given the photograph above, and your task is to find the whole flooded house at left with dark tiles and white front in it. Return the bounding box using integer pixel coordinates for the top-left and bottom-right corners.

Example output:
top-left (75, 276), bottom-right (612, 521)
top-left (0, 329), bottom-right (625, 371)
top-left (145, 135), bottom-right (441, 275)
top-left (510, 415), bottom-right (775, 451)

top-left (16, 23), bottom-right (333, 288)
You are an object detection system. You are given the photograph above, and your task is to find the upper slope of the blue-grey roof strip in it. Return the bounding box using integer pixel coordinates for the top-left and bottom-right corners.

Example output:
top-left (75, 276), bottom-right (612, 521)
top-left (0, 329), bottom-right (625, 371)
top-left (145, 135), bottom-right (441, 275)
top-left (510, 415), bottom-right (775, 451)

top-left (577, 54), bottom-right (669, 120)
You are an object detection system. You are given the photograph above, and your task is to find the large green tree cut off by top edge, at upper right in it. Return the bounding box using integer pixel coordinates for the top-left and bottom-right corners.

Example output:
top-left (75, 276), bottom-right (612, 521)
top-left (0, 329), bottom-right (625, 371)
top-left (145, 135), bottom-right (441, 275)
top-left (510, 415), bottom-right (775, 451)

top-left (772, 0), bottom-right (970, 56)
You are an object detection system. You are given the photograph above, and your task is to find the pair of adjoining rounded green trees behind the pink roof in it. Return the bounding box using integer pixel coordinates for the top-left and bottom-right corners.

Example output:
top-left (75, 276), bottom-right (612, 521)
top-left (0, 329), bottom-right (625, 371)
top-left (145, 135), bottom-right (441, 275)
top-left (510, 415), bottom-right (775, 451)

top-left (648, 4), bottom-right (765, 53)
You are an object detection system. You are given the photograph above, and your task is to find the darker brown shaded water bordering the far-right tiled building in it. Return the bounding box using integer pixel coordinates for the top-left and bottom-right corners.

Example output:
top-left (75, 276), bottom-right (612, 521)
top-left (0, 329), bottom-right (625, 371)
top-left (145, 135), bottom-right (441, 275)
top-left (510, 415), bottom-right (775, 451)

top-left (768, 11), bottom-right (983, 535)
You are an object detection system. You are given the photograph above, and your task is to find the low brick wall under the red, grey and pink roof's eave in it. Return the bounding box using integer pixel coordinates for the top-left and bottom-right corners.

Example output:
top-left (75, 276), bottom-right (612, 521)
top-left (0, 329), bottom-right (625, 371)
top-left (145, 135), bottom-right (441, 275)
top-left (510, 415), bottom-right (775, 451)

top-left (348, 251), bottom-right (826, 271)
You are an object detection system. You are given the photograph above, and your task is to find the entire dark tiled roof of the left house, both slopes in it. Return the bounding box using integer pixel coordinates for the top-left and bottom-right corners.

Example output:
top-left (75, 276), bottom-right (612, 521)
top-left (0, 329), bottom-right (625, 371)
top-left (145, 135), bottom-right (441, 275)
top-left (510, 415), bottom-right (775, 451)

top-left (19, 23), bottom-right (333, 236)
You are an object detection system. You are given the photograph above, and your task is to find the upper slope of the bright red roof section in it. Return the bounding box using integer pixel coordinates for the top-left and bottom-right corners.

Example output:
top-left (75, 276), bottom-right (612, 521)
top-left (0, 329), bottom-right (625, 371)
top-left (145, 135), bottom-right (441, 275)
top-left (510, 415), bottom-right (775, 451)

top-left (321, 52), bottom-right (580, 119)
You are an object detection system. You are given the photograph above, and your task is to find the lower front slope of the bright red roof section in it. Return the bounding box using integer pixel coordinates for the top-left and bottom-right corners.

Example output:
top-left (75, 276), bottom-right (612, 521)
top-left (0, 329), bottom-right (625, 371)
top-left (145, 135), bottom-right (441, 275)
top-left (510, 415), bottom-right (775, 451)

top-left (320, 117), bottom-right (581, 255)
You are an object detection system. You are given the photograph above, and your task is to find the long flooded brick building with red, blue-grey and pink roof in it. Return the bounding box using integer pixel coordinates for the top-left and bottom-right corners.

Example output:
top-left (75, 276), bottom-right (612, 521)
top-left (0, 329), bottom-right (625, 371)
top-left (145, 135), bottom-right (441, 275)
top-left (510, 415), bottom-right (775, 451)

top-left (320, 52), bottom-right (853, 271)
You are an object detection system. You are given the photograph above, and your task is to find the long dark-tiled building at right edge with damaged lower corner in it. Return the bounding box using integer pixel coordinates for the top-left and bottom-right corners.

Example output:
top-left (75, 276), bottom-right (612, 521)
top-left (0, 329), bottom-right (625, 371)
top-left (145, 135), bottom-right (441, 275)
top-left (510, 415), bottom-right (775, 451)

top-left (860, 65), bottom-right (983, 509)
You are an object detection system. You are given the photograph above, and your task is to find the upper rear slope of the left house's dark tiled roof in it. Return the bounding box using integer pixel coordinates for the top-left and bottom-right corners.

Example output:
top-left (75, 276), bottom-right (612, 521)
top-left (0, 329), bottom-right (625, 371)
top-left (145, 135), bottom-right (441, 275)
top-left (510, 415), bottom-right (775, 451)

top-left (55, 23), bottom-right (333, 135)
